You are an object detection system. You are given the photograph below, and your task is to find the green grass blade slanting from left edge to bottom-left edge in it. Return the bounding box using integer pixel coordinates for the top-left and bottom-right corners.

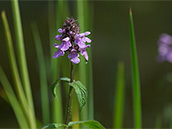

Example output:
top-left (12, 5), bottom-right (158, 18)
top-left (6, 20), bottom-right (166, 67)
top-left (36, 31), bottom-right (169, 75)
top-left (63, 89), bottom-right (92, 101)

top-left (0, 66), bottom-right (29, 129)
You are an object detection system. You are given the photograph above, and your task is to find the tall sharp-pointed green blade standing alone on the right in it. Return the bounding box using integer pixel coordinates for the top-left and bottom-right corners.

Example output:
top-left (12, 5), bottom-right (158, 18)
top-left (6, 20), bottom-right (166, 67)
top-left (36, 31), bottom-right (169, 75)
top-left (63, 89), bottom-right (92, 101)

top-left (130, 9), bottom-right (142, 129)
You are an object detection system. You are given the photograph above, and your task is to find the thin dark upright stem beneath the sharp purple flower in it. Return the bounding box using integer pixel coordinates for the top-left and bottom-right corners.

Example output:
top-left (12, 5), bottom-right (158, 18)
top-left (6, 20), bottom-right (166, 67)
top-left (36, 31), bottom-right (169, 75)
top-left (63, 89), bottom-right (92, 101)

top-left (65, 62), bottom-right (74, 125)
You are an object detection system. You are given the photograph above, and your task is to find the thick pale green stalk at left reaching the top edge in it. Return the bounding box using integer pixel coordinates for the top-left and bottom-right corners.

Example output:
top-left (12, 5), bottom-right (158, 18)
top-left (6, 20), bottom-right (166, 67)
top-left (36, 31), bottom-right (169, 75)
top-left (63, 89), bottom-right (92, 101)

top-left (11, 0), bottom-right (36, 128)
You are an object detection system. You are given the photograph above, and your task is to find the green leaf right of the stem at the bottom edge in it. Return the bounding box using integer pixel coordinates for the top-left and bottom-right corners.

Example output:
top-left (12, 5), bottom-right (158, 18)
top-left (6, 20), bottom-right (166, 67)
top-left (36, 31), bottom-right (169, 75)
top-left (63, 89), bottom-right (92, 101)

top-left (68, 120), bottom-right (105, 129)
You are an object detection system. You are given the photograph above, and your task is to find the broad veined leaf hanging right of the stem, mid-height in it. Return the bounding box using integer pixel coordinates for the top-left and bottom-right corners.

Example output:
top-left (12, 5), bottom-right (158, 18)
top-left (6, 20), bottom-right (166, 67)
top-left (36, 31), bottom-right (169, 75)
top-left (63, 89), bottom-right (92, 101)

top-left (69, 81), bottom-right (87, 110)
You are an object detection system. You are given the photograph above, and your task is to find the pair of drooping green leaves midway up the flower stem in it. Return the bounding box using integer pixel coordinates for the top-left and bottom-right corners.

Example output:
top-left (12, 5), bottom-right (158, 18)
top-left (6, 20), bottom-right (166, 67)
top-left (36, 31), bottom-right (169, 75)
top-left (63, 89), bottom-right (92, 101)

top-left (50, 77), bottom-right (87, 110)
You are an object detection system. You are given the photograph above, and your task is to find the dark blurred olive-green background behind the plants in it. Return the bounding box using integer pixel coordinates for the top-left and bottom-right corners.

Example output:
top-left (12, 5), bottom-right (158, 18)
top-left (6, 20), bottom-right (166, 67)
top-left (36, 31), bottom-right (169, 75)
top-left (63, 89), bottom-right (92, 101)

top-left (0, 0), bottom-right (172, 128)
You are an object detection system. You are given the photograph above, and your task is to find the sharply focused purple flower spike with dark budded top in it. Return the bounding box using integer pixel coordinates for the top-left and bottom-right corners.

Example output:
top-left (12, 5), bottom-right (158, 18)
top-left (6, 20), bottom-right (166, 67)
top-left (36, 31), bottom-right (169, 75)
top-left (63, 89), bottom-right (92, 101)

top-left (53, 18), bottom-right (91, 64)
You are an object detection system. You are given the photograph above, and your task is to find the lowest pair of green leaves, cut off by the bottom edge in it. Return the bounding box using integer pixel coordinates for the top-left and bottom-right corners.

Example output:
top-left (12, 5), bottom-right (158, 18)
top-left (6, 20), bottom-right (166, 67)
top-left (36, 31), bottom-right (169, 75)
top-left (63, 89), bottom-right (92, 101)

top-left (42, 120), bottom-right (105, 129)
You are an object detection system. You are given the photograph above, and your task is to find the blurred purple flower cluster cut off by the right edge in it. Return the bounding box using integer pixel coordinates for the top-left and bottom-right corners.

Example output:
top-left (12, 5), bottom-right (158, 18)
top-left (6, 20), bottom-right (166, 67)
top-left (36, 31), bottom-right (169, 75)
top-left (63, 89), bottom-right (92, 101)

top-left (158, 33), bottom-right (172, 63)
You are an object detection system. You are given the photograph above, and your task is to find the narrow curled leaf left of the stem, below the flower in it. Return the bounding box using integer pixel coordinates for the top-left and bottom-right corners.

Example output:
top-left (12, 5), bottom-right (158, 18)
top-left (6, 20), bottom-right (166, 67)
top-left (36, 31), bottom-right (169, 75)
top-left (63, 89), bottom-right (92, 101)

top-left (50, 77), bottom-right (70, 98)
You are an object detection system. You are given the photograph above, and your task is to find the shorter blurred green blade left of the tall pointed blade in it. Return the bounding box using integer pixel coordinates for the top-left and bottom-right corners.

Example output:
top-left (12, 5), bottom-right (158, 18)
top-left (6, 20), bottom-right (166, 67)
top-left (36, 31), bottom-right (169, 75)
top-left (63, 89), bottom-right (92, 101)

top-left (113, 62), bottom-right (124, 129)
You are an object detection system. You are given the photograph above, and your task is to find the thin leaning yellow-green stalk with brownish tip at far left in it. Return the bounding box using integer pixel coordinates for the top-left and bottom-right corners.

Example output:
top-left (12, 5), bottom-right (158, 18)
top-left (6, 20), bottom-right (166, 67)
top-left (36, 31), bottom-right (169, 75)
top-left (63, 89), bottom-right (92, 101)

top-left (2, 11), bottom-right (35, 127)
